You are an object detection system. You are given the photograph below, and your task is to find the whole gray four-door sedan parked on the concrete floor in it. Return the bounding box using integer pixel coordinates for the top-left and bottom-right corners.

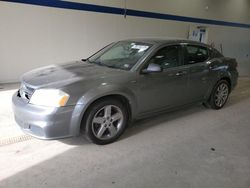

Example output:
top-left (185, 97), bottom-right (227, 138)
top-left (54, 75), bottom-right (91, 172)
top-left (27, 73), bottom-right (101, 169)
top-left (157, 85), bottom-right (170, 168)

top-left (13, 39), bottom-right (238, 144)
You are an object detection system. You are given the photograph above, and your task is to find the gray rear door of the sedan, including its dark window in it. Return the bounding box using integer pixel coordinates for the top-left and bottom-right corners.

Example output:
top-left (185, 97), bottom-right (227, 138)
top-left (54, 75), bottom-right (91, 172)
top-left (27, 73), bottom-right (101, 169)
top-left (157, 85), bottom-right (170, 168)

top-left (184, 44), bottom-right (209, 102)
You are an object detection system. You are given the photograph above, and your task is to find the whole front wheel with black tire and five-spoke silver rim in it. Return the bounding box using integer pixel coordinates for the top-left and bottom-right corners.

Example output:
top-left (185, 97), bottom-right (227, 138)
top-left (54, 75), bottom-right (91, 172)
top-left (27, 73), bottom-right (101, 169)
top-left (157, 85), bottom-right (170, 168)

top-left (83, 98), bottom-right (128, 145)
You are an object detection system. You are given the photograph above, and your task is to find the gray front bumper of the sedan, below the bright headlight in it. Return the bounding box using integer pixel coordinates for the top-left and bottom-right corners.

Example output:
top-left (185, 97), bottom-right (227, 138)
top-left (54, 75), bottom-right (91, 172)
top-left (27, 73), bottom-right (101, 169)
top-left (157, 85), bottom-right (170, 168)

top-left (12, 93), bottom-right (75, 139)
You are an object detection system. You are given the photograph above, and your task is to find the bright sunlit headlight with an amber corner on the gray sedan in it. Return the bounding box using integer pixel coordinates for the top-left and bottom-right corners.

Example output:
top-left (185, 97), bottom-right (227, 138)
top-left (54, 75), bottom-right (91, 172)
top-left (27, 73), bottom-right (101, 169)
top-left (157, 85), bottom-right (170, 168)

top-left (29, 89), bottom-right (69, 107)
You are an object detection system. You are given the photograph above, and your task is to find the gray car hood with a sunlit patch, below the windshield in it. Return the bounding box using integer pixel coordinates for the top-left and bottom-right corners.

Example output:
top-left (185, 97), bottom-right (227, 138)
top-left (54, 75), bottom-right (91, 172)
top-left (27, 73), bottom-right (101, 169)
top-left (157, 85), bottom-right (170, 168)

top-left (21, 61), bottom-right (126, 89)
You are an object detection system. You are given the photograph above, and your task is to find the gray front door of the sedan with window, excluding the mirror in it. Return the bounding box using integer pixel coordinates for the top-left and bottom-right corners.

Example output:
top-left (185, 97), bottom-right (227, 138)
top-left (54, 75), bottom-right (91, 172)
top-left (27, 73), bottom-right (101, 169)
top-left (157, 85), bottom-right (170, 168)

top-left (138, 45), bottom-right (188, 114)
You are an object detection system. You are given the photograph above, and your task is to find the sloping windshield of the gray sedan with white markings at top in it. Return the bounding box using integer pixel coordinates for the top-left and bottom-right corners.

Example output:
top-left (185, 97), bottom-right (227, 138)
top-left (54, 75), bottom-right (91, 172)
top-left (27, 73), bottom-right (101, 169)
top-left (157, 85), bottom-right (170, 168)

top-left (88, 41), bottom-right (152, 70)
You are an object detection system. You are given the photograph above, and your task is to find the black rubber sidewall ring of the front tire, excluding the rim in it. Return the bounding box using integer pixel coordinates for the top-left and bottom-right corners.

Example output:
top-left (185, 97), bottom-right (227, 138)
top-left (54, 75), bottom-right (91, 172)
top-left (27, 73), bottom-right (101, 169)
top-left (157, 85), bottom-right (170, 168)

top-left (84, 99), bottom-right (128, 145)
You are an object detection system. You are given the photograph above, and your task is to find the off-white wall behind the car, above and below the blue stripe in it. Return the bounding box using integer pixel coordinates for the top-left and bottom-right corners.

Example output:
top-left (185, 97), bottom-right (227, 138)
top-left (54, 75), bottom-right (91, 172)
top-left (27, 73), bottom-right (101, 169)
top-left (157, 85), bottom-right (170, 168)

top-left (0, 0), bottom-right (250, 83)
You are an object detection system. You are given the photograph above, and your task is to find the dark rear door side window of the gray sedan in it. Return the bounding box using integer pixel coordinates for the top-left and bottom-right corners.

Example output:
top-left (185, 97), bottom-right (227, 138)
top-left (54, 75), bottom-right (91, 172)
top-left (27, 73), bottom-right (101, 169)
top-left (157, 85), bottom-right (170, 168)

top-left (185, 45), bottom-right (208, 64)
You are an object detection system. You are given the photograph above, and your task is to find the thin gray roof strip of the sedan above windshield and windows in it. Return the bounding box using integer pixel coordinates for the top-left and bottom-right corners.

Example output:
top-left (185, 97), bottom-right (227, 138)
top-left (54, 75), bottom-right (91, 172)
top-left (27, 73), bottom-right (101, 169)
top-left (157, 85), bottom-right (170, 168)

top-left (122, 38), bottom-right (210, 47)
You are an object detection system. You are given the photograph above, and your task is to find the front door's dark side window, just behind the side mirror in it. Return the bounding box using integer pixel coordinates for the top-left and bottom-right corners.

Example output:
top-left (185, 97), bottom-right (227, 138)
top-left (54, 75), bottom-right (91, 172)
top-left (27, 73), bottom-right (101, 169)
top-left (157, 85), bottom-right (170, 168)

top-left (149, 45), bottom-right (181, 69)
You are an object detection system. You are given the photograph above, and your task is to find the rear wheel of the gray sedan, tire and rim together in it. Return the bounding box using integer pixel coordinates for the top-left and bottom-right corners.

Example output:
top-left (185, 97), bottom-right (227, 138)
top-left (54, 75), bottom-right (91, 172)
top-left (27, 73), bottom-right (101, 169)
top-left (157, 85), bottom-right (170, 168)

top-left (209, 80), bottom-right (230, 110)
